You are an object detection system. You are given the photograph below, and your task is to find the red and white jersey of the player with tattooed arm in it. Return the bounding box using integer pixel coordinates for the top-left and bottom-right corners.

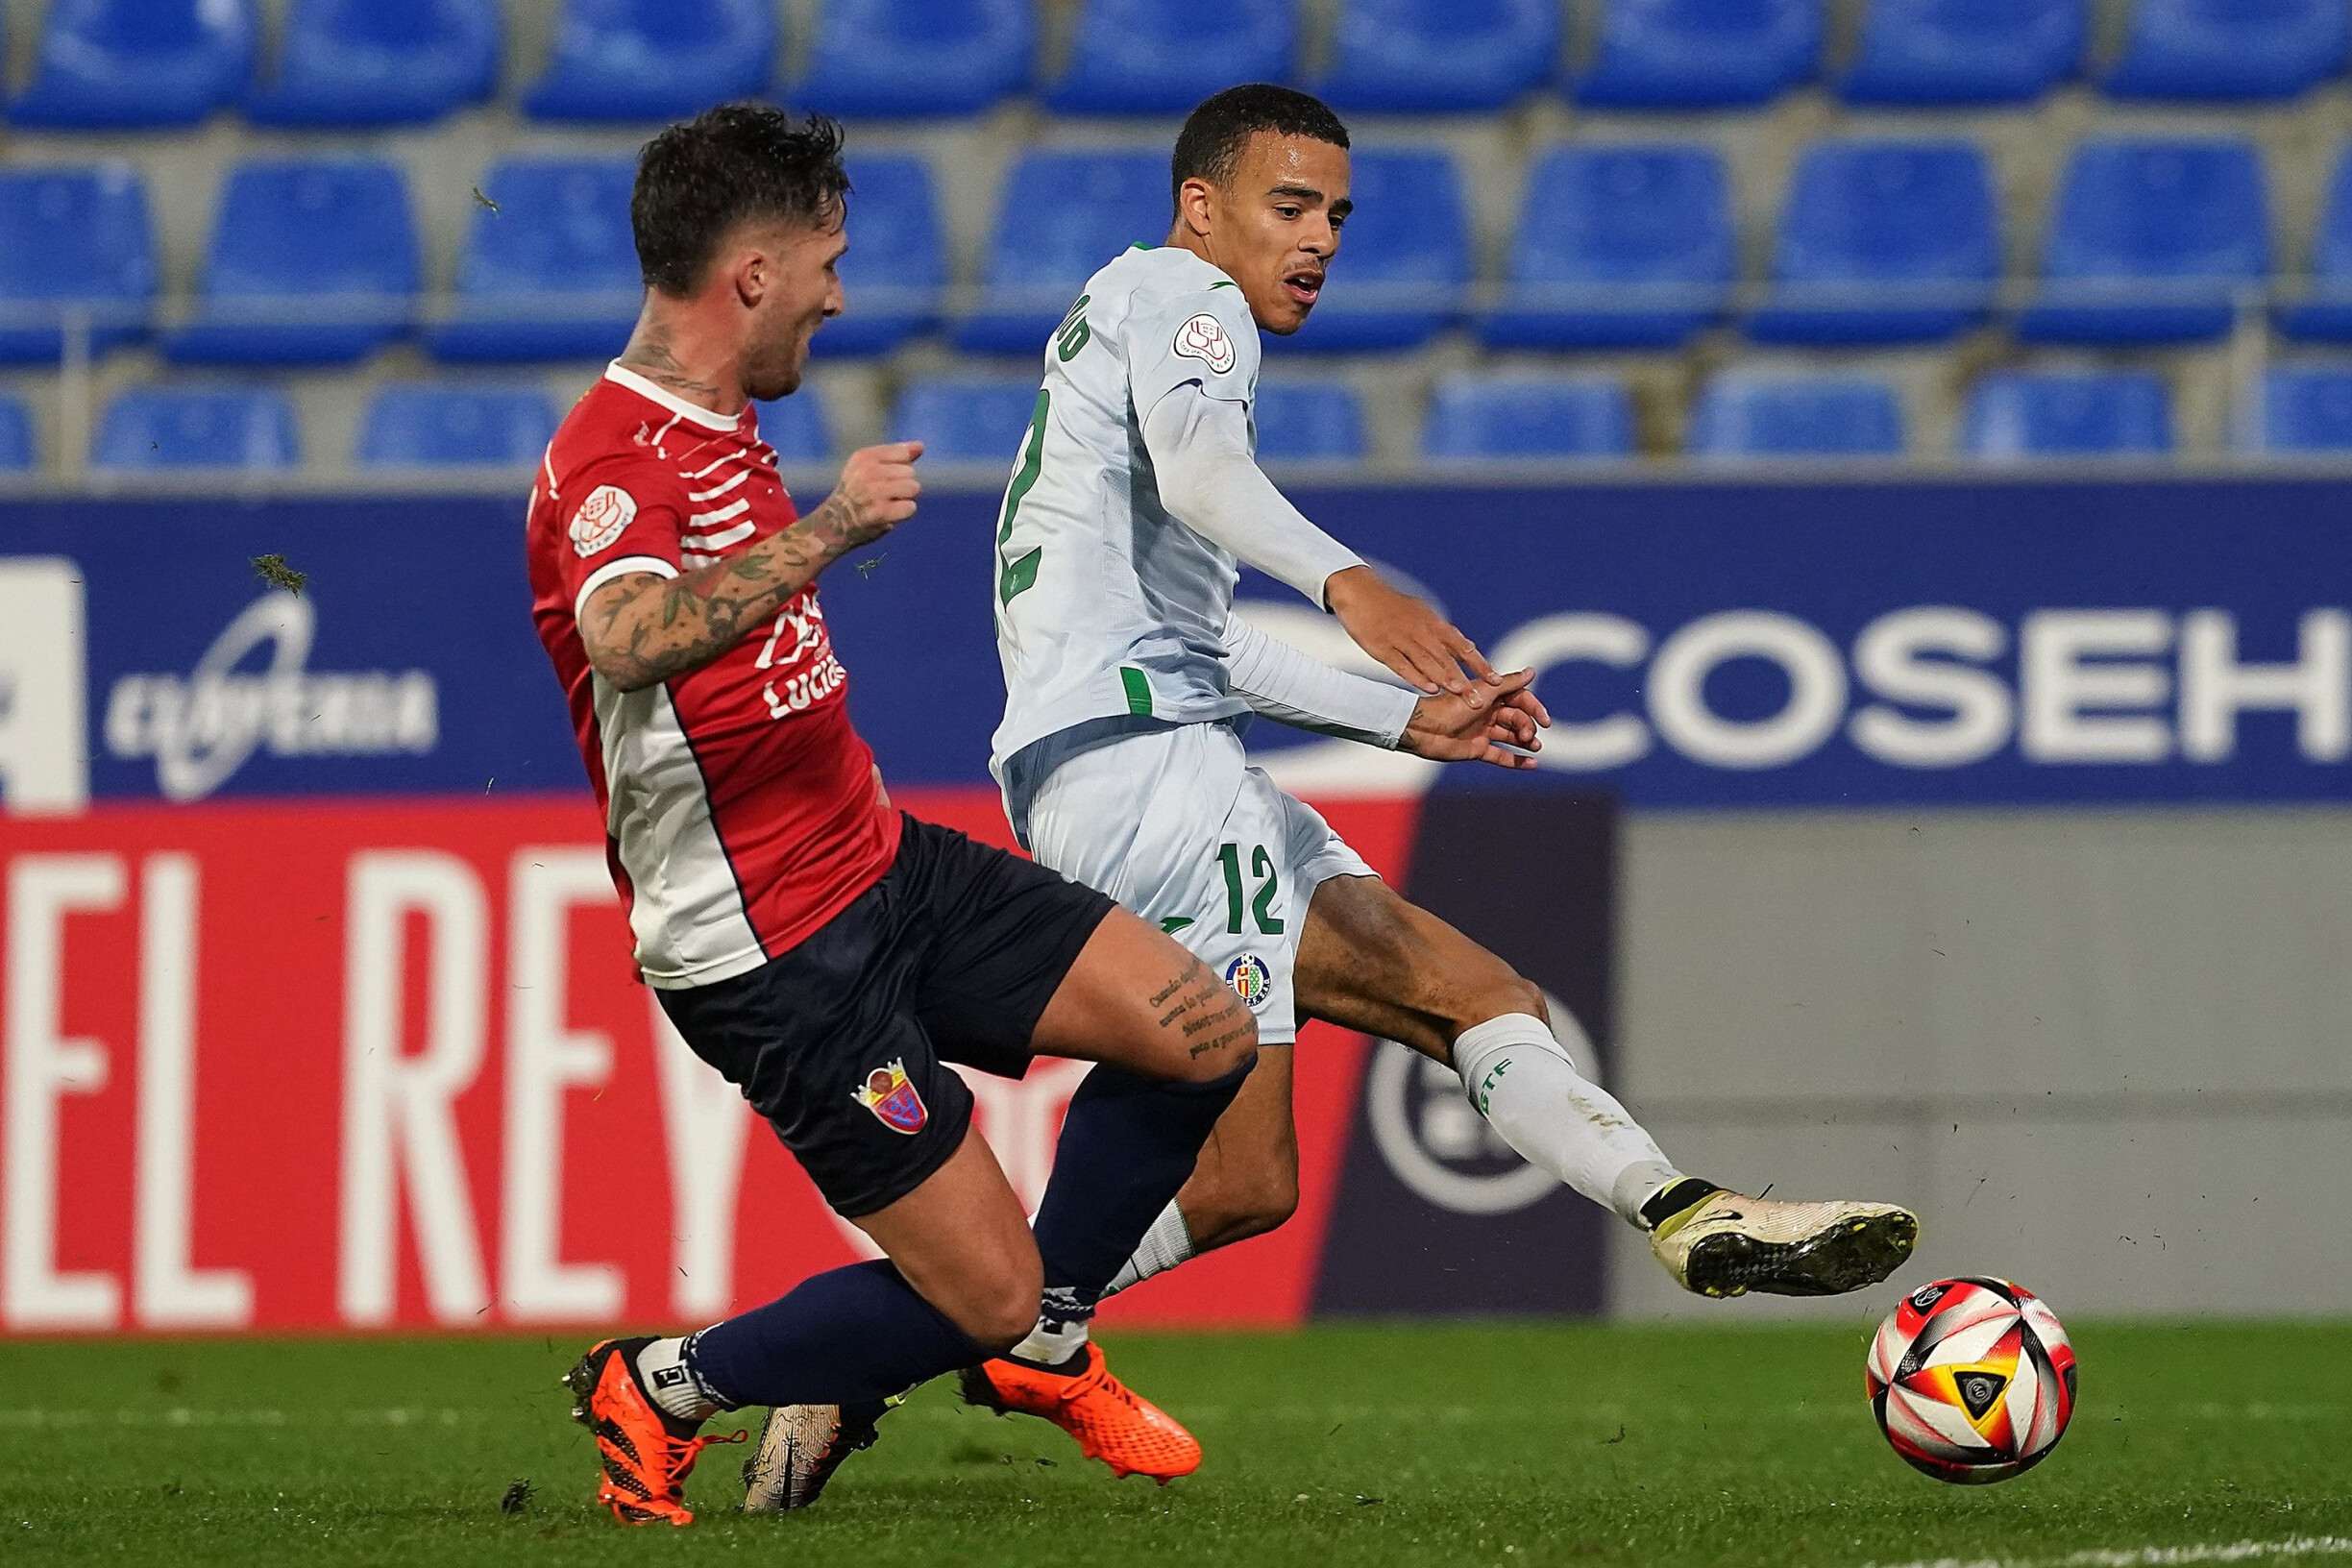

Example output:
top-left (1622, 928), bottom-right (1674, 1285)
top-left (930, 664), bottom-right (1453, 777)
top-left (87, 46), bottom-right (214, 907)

top-left (529, 364), bottom-right (898, 990)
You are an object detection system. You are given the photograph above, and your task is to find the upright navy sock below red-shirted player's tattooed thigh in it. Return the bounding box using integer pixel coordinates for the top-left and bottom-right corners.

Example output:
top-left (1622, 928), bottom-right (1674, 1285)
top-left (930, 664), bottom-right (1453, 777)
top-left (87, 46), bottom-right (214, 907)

top-left (1033, 1058), bottom-right (1256, 1321)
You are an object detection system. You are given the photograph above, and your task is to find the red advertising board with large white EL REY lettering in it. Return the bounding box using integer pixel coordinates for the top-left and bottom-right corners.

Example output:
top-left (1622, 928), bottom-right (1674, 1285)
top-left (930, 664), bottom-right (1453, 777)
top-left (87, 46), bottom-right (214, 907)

top-left (0, 790), bottom-right (1416, 1333)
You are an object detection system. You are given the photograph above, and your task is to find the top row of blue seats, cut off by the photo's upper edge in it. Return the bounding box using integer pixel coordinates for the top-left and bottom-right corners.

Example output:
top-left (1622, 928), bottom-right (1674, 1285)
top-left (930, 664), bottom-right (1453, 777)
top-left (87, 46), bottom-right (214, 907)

top-left (7, 0), bottom-right (2347, 127)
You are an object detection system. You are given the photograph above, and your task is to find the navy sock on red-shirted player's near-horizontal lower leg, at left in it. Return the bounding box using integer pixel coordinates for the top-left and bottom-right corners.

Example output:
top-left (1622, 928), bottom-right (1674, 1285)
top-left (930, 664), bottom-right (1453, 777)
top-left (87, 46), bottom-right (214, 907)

top-left (687, 1262), bottom-right (988, 1410)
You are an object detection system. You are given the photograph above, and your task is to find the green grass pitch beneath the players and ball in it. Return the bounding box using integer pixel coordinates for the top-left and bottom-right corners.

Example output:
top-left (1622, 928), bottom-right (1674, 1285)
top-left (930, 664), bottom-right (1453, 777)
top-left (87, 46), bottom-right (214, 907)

top-left (0, 1307), bottom-right (2352, 1568)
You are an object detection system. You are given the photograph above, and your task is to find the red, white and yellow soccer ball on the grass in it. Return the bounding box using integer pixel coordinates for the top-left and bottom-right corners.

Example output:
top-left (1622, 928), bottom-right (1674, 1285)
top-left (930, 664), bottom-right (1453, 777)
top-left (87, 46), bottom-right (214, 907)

top-left (1868, 1279), bottom-right (2074, 1485)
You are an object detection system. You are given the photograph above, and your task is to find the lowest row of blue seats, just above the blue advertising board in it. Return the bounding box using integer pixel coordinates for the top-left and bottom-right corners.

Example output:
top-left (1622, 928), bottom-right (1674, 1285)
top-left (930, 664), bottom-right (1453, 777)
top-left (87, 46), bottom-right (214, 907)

top-left (13, 367), bottom-right (2352, 473)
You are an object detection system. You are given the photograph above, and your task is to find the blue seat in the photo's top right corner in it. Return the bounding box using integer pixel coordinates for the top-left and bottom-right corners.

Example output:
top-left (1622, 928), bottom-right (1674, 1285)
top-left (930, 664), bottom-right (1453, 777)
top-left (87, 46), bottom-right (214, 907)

top-left (2100, 0), bottom-right (2352, 101)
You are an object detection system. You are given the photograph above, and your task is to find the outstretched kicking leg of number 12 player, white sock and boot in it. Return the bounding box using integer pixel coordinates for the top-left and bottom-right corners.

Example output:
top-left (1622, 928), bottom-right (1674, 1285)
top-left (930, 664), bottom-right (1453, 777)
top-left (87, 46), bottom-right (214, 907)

top-left (1298, 870), bottom-right (1920, 1295)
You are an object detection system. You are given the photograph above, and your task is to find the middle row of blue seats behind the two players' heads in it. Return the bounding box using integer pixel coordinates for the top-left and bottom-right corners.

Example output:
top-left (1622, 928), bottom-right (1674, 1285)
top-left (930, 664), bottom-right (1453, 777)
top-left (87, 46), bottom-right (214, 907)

top-left (13, 138), bottom-right (2352, 364)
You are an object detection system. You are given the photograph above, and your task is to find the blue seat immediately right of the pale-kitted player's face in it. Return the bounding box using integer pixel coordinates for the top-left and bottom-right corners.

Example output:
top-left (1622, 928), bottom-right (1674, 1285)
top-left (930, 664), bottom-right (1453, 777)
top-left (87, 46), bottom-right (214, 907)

top-left (1265, 148), bottom-right (1470, 353)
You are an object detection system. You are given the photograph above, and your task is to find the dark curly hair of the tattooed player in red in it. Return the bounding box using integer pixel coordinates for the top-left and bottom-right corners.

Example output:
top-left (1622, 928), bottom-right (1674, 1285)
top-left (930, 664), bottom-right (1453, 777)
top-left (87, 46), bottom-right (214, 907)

top-left (628, 104), bottom-right (849, 299)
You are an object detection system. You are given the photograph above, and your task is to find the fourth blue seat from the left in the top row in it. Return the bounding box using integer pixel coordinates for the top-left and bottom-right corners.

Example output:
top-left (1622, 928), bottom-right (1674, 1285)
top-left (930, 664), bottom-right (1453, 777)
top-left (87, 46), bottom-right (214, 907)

top-left (786, 0), bottom-right (1038, 120)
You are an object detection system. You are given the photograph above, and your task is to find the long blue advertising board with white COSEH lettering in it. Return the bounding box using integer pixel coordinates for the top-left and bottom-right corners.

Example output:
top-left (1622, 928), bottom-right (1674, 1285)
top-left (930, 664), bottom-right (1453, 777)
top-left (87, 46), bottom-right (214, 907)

top-left (0, 479), bottom-right (2352, 809)
